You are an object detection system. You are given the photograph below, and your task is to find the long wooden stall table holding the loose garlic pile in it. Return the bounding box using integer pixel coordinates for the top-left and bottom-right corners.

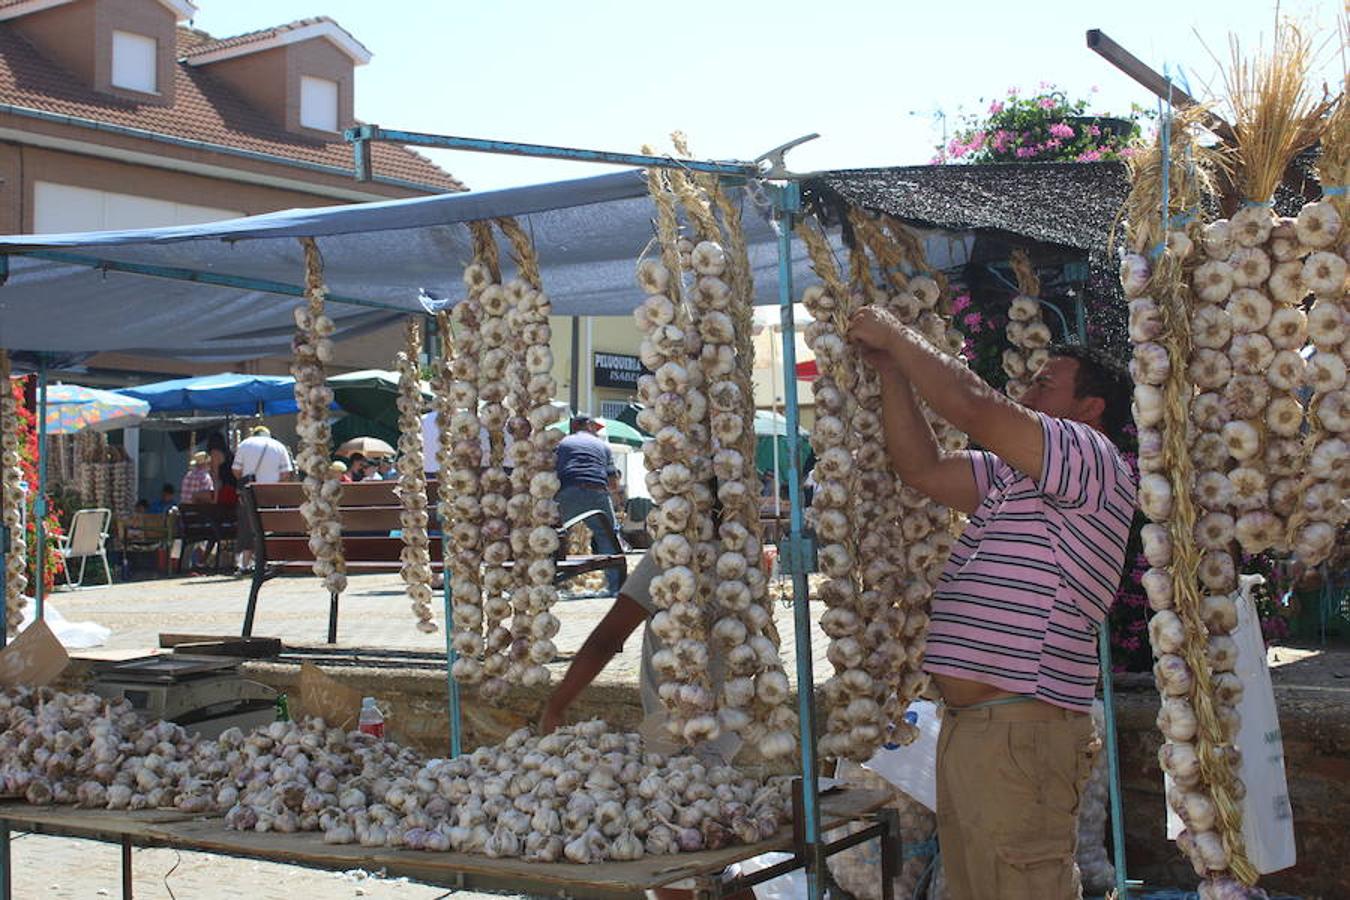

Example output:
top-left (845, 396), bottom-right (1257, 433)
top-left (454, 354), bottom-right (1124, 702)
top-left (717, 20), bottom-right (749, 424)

top-left (0, 788), bottom-right (899, 900)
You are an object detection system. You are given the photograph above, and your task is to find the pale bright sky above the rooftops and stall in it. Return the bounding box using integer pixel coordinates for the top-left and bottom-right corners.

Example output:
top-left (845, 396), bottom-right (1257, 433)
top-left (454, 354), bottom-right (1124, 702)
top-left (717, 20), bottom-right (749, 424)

top-left (193, 0), bottom-right (1343, 190)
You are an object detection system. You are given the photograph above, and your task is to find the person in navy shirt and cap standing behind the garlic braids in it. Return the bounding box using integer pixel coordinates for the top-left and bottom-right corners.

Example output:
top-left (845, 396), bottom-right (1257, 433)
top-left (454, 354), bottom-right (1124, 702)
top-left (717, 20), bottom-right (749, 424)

top-left (558, 414), bottom-right (624, 596)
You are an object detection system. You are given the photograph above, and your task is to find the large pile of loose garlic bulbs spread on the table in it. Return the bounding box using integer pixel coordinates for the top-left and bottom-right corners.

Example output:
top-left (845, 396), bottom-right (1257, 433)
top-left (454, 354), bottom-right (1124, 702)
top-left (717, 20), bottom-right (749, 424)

top-left (0, 688), bottom-right (791, 862)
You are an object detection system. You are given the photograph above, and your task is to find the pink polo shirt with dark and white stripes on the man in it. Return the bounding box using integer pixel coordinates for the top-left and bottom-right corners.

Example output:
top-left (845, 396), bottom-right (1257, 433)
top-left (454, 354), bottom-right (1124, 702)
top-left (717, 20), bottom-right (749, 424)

top-left (923, 413), bottom-right (1135, 710)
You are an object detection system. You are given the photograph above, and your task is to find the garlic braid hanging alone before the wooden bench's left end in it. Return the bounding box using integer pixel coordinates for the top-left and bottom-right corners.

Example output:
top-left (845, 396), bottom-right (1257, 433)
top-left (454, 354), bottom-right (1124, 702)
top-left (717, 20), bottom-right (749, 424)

top-left (290, 237), bottom-right (347, 594)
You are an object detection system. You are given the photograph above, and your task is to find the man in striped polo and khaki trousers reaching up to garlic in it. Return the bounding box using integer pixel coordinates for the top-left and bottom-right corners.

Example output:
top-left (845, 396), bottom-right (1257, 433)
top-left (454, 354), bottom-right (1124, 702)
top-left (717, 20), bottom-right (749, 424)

top-left (849, 308), bottom-right (1135, 900)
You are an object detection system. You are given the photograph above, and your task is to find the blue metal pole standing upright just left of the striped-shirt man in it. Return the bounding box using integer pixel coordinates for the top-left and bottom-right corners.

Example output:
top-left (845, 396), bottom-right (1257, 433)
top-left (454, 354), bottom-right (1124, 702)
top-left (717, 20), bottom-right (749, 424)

top-left (771, 182), bottom-right (824, 899)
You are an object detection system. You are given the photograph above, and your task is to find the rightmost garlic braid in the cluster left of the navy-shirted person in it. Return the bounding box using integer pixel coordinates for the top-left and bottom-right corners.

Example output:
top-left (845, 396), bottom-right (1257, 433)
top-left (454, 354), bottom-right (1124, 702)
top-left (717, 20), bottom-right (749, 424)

top-left (497, 219), bottom-right (563, 687)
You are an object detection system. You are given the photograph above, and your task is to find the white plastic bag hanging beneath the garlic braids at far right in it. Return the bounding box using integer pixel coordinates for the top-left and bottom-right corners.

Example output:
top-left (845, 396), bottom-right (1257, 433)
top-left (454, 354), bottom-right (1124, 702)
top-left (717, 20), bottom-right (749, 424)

top-left (1168, 575), bottom-right (1297, 874)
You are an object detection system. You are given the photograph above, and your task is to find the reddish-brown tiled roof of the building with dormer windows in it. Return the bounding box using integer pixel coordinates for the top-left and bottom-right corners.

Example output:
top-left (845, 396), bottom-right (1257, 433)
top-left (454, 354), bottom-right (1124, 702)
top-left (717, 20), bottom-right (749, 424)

top-left (0, 22), bottom-right (466, 192)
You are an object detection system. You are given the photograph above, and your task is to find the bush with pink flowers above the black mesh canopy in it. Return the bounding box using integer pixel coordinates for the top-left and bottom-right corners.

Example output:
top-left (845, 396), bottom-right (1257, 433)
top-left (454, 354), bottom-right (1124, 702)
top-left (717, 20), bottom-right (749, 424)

top-left (933, 82), bottom-right (1148, 163)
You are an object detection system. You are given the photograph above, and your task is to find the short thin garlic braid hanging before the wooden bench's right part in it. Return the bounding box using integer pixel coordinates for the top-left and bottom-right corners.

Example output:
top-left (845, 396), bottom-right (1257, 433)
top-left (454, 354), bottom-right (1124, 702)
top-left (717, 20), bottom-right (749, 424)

top-left (394, 318), bottom-right (436, 633)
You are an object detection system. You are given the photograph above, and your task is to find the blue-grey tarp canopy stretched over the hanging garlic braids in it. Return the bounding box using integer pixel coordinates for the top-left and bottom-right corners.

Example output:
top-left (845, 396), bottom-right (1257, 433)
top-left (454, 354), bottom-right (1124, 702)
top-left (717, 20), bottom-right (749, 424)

top-left (0, 171), bottom-right (969, 362)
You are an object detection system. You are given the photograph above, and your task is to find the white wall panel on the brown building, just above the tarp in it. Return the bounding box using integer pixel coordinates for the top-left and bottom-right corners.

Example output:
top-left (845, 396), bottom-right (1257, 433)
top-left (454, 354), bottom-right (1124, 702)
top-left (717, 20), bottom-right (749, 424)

top-left (32, 181), bottom-right (243, 235)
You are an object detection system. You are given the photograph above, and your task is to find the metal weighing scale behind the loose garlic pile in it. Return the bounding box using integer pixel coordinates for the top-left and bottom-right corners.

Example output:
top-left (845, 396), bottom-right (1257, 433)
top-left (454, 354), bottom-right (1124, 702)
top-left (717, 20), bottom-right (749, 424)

top-left (90, 653), bottom-right (277, 738)
